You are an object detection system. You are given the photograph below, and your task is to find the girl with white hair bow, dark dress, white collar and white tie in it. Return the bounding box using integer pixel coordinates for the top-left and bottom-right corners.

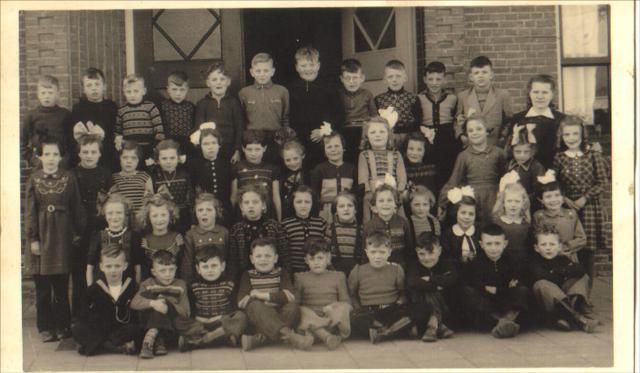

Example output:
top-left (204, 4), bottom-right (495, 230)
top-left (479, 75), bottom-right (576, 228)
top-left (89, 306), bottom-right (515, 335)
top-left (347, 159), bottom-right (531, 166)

top-left (441, 186), bottom-right (480, 266)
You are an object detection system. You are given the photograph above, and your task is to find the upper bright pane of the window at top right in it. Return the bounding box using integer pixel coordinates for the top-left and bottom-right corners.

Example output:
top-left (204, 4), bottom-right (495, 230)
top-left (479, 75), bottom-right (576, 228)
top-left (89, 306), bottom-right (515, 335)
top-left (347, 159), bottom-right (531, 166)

top-left (562, 5), bottom-right (609, 58)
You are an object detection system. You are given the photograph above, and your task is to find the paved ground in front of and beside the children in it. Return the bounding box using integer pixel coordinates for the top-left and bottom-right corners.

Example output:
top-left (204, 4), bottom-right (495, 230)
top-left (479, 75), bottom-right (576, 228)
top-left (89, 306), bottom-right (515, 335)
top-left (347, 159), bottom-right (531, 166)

top-left (23, 278), bottom-right (613, 371)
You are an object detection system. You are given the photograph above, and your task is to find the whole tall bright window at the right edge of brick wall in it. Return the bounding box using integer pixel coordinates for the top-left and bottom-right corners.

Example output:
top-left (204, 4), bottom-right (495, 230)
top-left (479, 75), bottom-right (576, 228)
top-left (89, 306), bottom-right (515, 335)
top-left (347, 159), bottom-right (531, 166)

top-left (560, 5), bottom-right (611, 132)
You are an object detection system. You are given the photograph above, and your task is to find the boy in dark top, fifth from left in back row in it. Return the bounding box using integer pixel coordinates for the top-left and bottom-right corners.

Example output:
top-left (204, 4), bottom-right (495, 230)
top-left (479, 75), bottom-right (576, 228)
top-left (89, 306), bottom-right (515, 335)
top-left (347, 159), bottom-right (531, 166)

top-left (196, 60), bottom-right (244, 163)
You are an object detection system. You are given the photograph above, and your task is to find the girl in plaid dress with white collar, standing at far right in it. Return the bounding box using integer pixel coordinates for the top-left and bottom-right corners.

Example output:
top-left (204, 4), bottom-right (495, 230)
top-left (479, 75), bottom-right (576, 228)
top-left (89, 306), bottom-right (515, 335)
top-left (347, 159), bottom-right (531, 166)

top-left (553, 116), bottom-right (607, 289)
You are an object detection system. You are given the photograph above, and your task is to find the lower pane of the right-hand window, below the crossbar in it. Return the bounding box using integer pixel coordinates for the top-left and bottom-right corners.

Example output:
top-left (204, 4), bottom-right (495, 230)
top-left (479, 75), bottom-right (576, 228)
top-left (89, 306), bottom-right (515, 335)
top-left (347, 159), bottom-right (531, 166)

top-left (562, 66), bottom-right (610, 131)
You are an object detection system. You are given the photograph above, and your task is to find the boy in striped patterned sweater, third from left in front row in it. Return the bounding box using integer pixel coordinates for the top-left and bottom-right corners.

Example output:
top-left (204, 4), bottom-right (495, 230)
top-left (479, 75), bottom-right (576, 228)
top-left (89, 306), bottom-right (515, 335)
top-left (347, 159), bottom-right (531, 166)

top-left (176, 245), bottom-right (247, 352)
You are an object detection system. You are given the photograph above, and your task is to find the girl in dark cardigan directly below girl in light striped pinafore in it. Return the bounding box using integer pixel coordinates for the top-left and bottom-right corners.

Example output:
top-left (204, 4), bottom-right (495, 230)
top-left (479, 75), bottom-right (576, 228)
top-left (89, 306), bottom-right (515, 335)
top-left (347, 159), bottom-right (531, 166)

top-left (362, 180), bottom-right (415, 269)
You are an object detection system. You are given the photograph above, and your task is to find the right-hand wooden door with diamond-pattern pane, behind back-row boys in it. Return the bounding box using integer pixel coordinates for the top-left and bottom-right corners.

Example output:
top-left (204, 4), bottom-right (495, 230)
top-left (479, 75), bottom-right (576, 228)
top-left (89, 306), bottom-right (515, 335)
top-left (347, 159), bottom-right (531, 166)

top-left (342, 7), bottom-right (417, 95)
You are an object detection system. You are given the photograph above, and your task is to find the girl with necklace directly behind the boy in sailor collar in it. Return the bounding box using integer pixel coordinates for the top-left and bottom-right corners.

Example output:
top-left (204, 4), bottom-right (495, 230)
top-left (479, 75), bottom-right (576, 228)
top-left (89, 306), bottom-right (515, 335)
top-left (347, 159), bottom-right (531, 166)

top-left (85, 190), bottom-right (144, 287)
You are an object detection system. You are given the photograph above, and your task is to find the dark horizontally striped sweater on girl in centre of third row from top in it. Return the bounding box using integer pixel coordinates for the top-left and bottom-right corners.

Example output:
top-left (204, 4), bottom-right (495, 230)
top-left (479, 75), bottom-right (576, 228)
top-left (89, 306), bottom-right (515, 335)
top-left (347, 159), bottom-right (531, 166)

top-left (281, 216), bottom-right (327, 273)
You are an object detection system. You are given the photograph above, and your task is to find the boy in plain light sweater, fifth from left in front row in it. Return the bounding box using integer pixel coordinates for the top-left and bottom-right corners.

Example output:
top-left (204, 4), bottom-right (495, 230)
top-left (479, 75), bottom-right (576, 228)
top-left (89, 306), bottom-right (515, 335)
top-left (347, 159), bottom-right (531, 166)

top-left (294, 238), bottom-right (352, 350)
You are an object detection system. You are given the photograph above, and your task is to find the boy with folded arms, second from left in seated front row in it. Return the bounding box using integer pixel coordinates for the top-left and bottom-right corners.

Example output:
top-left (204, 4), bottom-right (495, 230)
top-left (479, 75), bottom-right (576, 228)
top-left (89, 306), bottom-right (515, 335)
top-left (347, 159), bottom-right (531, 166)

top-left (131, 250), bottom-right (190, 359)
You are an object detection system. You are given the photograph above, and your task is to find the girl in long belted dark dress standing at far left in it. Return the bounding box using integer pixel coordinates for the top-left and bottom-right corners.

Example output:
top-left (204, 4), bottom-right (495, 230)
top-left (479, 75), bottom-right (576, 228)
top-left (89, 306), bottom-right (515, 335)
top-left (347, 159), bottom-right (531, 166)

top-left (24, 137), bottom-right (86, 342)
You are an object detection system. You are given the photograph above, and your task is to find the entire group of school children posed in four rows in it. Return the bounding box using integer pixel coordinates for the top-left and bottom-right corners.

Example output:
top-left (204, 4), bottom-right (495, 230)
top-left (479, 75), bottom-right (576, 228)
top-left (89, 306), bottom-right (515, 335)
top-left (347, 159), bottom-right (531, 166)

top-left (21, 47), bottom-right (608, 358)
